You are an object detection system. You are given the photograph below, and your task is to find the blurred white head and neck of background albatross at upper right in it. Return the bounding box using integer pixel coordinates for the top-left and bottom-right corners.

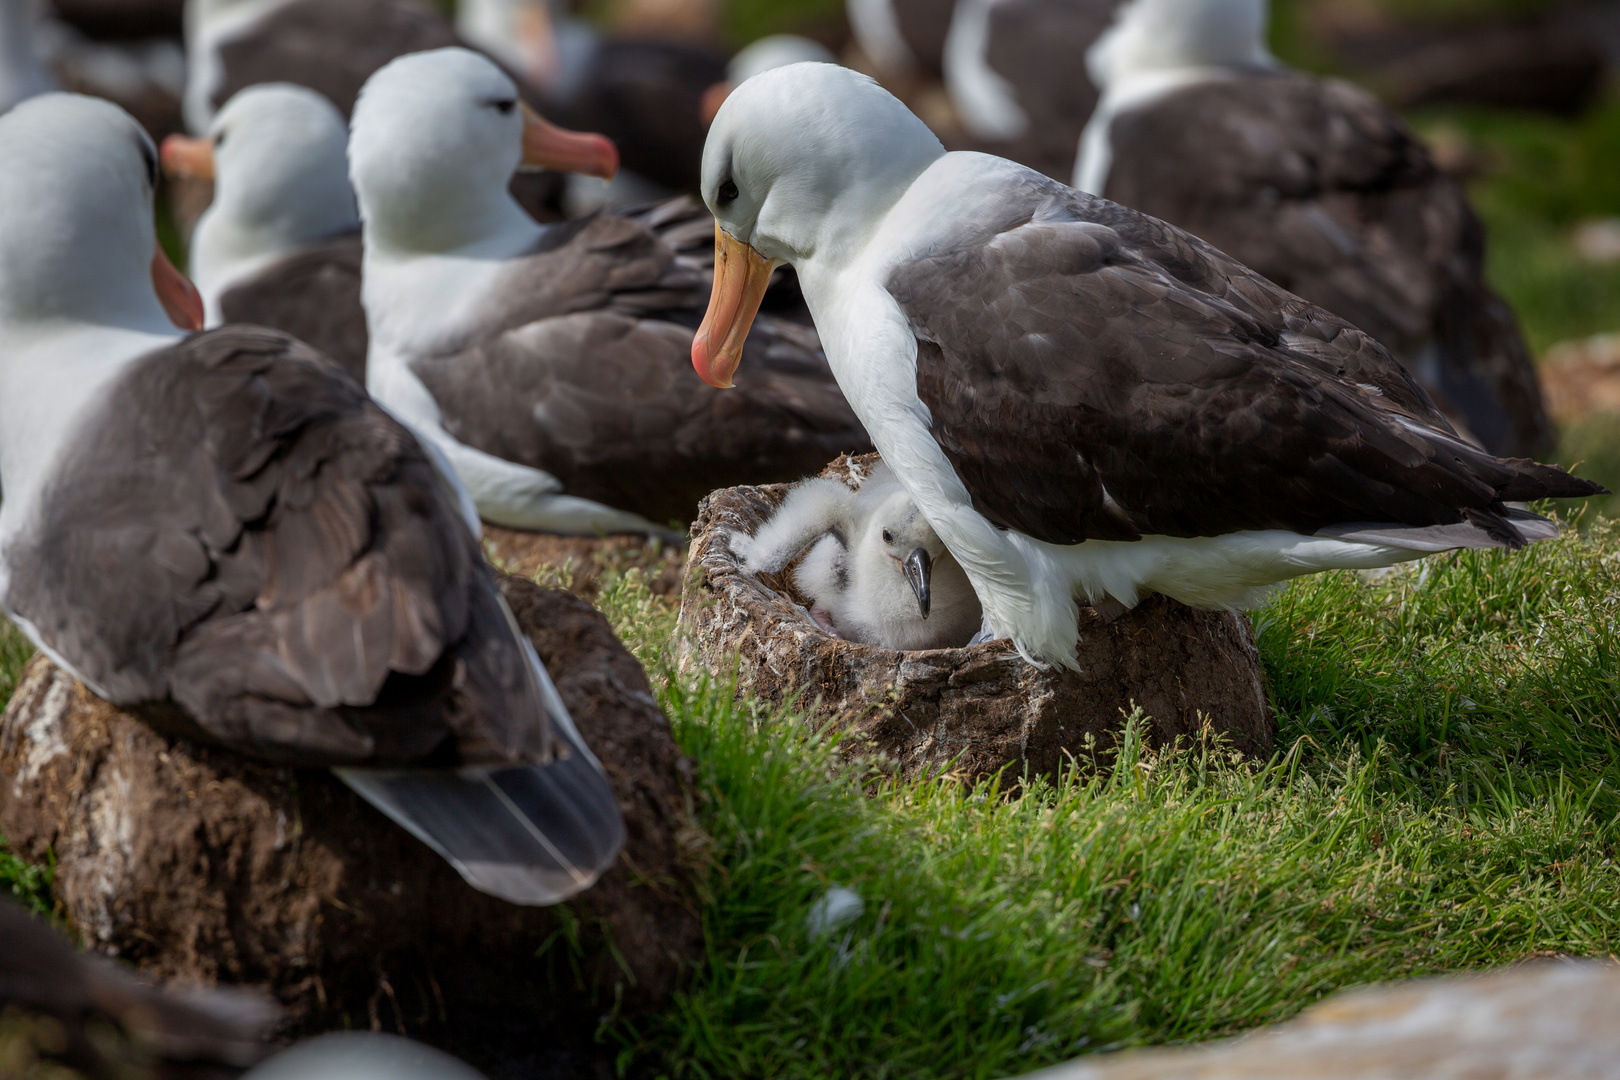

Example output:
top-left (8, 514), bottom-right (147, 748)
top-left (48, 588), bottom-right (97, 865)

top-left (1074, 0), bottom-right (1277, 194)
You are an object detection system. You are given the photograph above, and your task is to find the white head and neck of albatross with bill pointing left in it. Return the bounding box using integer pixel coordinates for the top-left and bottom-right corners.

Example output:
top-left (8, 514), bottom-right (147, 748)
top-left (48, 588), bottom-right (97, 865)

top-left (162, 83), bottom-right (360, 325)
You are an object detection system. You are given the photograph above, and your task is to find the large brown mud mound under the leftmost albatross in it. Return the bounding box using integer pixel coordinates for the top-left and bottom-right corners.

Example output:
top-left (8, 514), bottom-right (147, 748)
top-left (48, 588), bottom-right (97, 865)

top-left (0, 575), bottom-right (703, 1069)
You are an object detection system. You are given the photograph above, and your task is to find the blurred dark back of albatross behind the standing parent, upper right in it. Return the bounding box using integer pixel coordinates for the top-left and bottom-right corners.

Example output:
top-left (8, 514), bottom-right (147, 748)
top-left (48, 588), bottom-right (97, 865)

top-left (1106, 73), bottom-right (1552, 453)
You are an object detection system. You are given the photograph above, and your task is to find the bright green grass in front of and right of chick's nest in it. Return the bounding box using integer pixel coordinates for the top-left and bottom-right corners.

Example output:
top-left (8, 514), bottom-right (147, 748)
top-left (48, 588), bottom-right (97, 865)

top-left (570, 523), bottom-right (1620, 1077)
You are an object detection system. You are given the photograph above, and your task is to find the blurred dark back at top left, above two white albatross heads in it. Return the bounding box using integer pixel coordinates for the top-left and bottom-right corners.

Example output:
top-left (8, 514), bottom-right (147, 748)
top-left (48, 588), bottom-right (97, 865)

top-left (212, 0), bottom-right (462, 117)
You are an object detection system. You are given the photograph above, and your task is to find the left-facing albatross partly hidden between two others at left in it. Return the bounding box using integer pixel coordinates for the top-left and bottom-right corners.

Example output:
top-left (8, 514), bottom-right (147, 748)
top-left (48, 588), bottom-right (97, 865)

top-left (162, 83), bottom-right (366, 382)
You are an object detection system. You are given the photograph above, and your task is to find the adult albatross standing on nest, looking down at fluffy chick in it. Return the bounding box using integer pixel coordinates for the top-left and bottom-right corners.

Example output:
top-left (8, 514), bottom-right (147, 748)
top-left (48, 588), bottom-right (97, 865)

top-left (692, 63), bottom-right (1601, 665)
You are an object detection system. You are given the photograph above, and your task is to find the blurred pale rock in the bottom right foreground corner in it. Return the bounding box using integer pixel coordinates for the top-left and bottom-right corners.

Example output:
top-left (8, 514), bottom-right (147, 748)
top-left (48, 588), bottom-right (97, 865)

top-left (1027, 962), bottom-right (1620, 1080)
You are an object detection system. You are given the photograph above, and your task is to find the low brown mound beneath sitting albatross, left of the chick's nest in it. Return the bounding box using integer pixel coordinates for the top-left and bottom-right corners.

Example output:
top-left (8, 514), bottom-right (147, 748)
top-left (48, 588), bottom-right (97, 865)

top-left (484, 523), bottom-right (685, 601)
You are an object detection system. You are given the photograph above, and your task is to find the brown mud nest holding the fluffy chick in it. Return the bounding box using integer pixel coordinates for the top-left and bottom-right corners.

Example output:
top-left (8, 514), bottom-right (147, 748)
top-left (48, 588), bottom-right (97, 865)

top-left (680, 455), bottom-right (1275, 777)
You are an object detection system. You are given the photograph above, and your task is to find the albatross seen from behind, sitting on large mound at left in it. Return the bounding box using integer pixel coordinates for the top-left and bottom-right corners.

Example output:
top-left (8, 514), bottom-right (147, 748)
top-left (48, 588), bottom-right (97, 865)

top-left (0, 94), bottom-right (624, 904)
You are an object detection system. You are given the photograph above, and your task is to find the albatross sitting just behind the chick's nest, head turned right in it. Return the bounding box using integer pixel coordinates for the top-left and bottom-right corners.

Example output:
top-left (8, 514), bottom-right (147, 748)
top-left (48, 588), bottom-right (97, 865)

top-left (350, 49), bottom-right (867, 534)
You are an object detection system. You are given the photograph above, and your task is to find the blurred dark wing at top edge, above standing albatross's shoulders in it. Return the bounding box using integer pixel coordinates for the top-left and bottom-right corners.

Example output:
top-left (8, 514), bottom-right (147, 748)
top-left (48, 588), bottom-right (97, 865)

top-left (985, 0), bottom-right (1118, 181)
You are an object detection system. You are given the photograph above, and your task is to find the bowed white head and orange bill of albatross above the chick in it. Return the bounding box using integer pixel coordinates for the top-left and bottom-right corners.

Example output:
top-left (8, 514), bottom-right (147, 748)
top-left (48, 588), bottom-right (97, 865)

top-left (692, 63), bottom-right (944, 387)
